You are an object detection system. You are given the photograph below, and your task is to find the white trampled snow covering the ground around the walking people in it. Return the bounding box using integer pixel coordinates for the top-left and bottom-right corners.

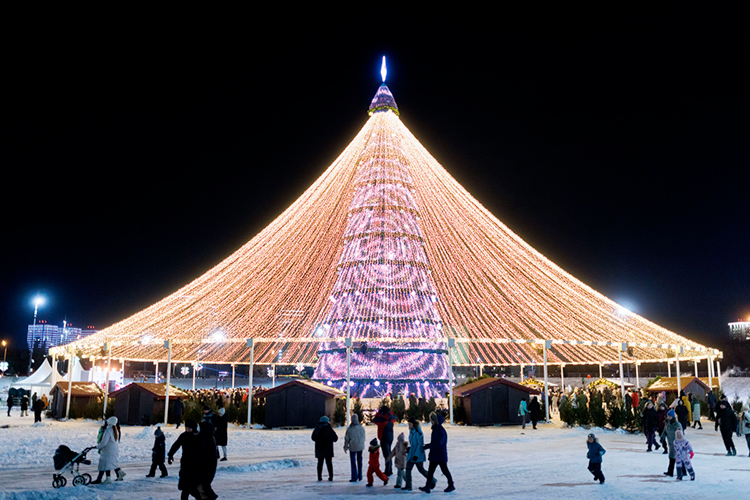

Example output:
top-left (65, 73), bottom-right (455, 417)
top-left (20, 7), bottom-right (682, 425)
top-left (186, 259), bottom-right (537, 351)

top-left (0, 378), bottom-right (750, 500)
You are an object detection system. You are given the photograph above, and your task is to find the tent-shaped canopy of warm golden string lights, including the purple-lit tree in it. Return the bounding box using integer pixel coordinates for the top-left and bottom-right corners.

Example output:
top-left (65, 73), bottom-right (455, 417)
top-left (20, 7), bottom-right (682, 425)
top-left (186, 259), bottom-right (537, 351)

top-left (52, 66), bottom-right (718, 384)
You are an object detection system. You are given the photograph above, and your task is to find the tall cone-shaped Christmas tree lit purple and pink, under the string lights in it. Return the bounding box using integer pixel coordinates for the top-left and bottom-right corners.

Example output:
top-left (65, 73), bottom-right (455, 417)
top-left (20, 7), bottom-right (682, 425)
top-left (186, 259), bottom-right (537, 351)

top-left (314, 83), bottom-right (448, 396)
